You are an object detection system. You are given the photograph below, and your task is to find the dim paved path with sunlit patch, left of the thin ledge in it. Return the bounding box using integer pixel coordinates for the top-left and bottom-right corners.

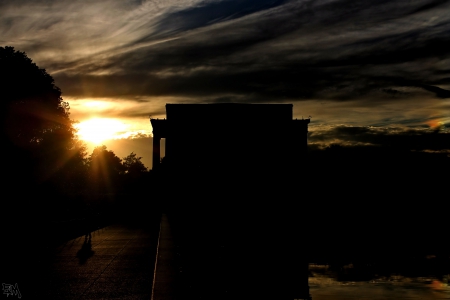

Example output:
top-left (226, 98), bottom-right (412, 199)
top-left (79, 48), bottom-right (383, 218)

top-left (2, 225), bottom-right (157, 299)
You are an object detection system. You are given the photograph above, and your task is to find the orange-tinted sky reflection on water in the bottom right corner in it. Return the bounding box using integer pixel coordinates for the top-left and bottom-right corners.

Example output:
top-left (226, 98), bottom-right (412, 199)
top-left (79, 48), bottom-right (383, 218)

top-left (309, 264), bottom-right (450, 300)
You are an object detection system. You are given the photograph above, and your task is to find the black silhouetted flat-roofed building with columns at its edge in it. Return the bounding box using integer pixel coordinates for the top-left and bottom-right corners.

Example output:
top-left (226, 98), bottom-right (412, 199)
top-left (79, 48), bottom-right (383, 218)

top-left (151, 103), bottom-right (310, 168)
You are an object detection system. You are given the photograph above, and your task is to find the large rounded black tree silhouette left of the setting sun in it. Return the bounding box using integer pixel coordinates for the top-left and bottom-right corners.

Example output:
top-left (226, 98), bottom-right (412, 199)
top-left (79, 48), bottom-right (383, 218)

top-left (0, 47), bottom-right (85, 199)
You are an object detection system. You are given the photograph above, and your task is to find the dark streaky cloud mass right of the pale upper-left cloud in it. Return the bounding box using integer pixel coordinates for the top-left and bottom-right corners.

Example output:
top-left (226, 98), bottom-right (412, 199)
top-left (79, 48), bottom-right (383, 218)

top-left (37, 0), bottom-right (450, 101)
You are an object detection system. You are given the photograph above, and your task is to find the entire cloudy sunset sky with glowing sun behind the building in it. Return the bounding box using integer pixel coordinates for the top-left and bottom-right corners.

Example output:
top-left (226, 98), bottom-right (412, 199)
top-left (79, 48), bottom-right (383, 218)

top-left (0, 0), bottom-right (450, 167)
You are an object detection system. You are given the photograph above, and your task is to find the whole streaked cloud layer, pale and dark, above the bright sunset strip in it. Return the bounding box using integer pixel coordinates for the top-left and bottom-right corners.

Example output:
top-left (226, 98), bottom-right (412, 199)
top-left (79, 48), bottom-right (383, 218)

top-left (1, 0), bottom-right (450, 100)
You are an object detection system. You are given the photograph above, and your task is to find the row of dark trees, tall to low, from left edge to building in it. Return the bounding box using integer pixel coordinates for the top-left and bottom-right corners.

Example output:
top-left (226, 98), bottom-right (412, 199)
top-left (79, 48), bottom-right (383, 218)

top-left (0, 47), bottom-right (148, 193)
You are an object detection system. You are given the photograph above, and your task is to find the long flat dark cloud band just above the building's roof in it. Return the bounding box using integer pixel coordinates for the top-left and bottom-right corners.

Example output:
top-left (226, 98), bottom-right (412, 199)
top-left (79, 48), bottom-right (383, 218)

top-left (55, 68), bottom-right (450, 102)
